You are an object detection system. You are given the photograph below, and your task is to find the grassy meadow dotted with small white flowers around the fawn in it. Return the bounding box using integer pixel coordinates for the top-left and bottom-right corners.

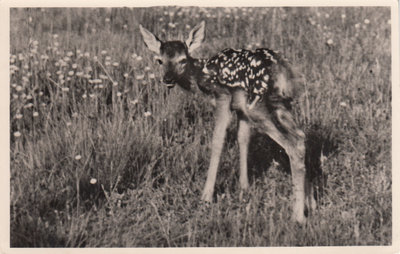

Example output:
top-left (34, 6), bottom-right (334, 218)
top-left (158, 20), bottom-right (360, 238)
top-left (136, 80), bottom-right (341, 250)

top-left (10, 7), bottom-right (392, 247)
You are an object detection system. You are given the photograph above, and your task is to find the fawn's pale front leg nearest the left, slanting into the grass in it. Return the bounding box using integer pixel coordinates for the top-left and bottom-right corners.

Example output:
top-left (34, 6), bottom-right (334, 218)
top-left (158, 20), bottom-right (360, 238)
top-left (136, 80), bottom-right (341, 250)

top-left (201, 94), bottom-right (232, 202)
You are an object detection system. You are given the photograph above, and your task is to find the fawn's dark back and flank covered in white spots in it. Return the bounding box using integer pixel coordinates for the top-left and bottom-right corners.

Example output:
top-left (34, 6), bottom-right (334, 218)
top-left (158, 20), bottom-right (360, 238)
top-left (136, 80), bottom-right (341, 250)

top-left (203, 48), bottom-right (295, 102)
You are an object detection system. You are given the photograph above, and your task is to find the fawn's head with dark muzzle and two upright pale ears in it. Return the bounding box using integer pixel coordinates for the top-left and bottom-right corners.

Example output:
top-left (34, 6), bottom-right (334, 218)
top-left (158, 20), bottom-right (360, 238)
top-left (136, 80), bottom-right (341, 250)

top-left (140, 21), bottom-right (205, 89)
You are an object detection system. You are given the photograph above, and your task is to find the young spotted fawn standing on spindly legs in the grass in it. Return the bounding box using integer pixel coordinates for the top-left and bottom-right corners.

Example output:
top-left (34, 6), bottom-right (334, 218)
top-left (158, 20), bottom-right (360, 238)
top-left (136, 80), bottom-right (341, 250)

top-left (140, 21), bottom-right (315, 223)
